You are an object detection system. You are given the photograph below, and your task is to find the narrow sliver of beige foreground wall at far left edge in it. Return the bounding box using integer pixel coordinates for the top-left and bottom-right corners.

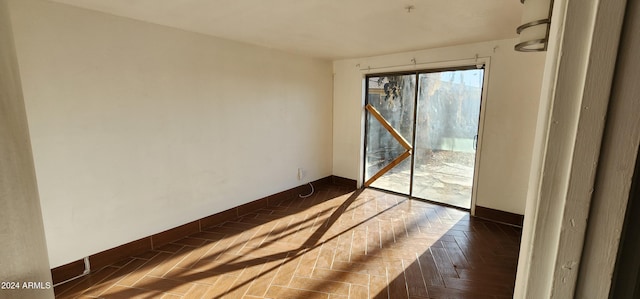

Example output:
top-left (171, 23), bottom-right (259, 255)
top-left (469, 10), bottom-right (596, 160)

top-left (0, 0), bottom-right (53, 299)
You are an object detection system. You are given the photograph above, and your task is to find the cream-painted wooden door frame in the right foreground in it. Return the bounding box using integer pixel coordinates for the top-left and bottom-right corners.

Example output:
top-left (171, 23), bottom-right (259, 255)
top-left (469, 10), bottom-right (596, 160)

top-left (514, 0), bottom-right (626, 298)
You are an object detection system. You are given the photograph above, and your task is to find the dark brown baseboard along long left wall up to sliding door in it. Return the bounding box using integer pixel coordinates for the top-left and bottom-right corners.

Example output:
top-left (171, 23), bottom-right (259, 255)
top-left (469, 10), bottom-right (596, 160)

top-left (51, 175), bottom-right (357, 284)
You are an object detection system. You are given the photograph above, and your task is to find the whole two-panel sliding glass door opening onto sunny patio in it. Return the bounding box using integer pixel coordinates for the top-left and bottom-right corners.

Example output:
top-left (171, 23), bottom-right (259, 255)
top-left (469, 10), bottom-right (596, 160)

top-left (364, 67), bottom-right (484, 209)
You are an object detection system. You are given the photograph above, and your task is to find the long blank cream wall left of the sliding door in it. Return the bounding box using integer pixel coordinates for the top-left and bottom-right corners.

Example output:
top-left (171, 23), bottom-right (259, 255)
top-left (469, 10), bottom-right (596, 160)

top-left (10, 0), bottom-right (332, 267)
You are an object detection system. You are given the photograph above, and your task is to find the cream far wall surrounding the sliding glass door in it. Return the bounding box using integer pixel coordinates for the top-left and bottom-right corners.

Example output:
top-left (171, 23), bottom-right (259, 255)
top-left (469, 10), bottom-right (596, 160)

top-left (333, 40), bottom-right (544, 214)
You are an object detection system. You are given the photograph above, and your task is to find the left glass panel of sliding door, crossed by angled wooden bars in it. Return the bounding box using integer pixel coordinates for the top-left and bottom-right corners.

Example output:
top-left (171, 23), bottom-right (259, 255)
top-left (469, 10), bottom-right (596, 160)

top-left (365, 74), bottom-right (416, 194)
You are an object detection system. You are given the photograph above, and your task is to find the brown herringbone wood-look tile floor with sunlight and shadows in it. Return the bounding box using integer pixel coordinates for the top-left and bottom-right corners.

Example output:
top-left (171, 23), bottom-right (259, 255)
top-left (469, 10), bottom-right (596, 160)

top-left (55, 186), bottom-right (521, 299)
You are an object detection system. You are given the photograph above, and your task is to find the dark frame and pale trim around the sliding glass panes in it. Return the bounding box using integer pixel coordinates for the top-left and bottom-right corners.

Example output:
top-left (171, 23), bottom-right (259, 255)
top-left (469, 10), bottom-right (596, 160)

top-left (362, 62), bottom-right (491, 215)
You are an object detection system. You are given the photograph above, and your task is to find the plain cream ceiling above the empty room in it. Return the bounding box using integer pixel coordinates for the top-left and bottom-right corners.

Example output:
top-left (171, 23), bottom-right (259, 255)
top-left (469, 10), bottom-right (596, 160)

top-left (51, 0), bottom-right (522, 60)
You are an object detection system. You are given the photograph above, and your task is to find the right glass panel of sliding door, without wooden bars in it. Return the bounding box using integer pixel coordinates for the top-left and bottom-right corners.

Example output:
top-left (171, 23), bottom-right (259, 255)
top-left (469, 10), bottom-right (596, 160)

top-left (412, 69), bottom-right (484, 209)
